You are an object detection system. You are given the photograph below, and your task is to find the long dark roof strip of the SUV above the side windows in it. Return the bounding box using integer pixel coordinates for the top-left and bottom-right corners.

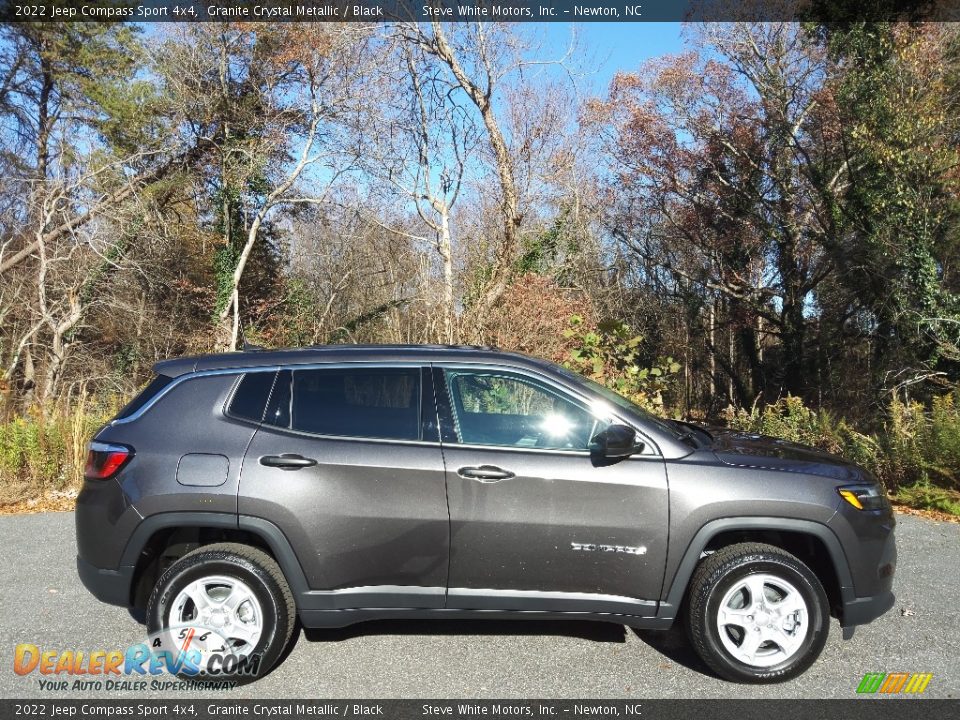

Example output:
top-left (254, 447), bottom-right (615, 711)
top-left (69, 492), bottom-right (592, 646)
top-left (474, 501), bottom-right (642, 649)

top-left (153, 345), bottom-right (552, 377)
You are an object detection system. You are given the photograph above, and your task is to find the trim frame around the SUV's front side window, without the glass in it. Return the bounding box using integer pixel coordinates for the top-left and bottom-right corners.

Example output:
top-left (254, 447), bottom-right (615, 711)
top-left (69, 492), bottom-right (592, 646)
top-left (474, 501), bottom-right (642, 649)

top-left (431, 362), bottom-right (663, 459)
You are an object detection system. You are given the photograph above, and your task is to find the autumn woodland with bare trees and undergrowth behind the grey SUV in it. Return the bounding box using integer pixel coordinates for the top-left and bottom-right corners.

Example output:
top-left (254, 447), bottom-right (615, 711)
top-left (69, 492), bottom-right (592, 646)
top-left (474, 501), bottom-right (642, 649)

top-left (0, 23), bottom-right (960, 514)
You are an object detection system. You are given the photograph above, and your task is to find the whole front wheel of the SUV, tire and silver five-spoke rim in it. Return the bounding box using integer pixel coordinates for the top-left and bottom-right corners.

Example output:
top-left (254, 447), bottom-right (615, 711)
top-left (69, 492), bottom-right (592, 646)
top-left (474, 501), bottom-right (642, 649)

top-left (686, 543), bottom-right (830, 683)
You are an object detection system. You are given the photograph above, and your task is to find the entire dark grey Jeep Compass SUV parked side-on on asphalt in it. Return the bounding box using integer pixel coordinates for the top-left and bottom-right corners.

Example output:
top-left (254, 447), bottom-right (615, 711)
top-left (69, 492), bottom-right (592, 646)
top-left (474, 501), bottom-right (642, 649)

top-left (76, 346), bottom-right (896, 682)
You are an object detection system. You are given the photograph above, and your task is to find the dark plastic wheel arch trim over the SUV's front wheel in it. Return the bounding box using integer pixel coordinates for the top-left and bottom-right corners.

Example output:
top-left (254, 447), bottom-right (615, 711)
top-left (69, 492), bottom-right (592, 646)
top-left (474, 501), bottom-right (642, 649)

top-left (657, 517), bottom-right (854, 618)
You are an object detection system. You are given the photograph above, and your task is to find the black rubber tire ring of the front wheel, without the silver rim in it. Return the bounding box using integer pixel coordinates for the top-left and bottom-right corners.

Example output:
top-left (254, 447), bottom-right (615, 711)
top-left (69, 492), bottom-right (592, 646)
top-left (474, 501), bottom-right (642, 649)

top-left (701, 557), bottom-right (829, 682)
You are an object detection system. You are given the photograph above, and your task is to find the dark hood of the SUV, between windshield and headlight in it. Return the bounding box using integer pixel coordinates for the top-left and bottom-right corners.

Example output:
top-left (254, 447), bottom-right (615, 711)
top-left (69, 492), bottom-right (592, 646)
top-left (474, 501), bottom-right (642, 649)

top-left (710, 428), bottom-right (864, 481)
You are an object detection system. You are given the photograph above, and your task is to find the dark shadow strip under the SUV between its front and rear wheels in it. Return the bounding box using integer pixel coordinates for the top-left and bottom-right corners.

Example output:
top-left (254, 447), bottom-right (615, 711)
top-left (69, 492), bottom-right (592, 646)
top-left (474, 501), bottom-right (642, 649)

top-left (303, 620), bottom-right (627, 643)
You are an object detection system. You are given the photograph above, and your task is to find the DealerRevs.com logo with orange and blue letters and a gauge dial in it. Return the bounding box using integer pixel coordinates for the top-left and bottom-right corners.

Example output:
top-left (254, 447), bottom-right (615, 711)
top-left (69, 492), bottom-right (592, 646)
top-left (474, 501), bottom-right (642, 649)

top-left (13, 626), bottom-right (260, 692)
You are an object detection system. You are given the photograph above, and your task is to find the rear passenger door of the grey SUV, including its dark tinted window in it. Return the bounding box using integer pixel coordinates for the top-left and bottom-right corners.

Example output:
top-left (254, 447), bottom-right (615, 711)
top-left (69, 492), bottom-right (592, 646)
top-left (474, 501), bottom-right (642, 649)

top-left (238, 364), bottom-right (449, 609)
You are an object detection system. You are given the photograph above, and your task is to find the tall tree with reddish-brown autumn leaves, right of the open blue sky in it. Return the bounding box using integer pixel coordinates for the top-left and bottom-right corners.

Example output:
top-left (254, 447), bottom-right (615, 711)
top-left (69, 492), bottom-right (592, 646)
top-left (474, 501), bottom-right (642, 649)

top-left (587, 23), bottom-right (843, 403)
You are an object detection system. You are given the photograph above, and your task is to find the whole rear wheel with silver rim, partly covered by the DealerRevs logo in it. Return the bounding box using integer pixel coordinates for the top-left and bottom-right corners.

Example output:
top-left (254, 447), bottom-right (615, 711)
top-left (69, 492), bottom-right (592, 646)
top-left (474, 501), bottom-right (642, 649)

top-left (147, 543), bottom-right (297, 683)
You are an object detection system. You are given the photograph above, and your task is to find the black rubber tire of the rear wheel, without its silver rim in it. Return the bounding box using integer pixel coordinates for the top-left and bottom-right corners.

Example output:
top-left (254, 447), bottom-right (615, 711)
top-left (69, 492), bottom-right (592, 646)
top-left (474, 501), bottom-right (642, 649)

top-left (147, 553), bottom-right (293, 682)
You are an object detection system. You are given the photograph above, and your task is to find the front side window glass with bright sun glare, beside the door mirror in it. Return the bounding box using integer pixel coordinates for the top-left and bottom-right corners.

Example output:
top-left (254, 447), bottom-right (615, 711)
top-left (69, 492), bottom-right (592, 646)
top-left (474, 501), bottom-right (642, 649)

top-left (444, 370), bottom-right (609, 450)
